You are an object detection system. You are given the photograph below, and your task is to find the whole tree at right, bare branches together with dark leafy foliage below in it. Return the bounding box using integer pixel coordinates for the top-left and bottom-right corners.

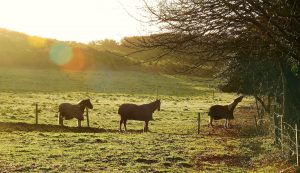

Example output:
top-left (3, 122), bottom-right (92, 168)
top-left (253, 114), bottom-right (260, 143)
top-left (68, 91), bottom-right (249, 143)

top-left (140, 0), bottom-right (300, 122)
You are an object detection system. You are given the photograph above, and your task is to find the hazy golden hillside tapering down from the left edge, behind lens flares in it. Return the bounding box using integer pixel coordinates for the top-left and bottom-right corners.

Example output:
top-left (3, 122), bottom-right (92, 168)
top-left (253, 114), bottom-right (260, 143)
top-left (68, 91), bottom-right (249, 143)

top-left (0, 29), bottom-right (138, 71)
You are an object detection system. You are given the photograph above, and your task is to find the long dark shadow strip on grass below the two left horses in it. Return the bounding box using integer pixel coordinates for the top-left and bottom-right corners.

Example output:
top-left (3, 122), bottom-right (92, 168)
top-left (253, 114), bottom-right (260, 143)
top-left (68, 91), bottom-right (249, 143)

top-left (0, 122), bottom-right (143, 133)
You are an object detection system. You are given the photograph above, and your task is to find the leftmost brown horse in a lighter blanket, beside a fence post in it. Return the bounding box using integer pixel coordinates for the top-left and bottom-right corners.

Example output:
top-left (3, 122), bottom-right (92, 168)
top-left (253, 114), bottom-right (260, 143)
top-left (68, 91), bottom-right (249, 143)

top-left (58, 99), bottom-right (93, 127)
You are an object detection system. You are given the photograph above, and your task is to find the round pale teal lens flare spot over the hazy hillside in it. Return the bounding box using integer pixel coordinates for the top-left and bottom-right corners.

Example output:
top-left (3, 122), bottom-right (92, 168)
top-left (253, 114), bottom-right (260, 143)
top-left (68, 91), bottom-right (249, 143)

top-left (49, 43), bottom-right (73, 66)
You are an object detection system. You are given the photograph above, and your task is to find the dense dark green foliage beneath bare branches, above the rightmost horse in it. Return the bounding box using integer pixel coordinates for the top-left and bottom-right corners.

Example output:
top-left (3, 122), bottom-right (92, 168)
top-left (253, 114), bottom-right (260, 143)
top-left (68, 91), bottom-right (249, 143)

top-left (219, 32), bottom-right (282, 97)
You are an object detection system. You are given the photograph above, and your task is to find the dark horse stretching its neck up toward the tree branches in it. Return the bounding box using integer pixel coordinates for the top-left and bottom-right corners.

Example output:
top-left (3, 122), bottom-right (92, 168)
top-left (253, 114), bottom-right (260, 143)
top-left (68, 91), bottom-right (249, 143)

top-left (208, 96), bottom-right (244, 128)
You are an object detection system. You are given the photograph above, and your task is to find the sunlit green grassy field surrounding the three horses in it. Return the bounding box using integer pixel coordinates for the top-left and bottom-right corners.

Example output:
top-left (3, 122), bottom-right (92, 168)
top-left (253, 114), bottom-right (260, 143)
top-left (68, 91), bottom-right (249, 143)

top-left (0, 68), bottom-right (283, 172)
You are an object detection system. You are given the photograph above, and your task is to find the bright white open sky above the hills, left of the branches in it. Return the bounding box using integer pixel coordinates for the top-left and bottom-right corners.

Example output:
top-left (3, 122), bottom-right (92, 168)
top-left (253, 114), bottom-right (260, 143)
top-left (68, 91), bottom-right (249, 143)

top-left (0, 0), bottom-right (155, 43)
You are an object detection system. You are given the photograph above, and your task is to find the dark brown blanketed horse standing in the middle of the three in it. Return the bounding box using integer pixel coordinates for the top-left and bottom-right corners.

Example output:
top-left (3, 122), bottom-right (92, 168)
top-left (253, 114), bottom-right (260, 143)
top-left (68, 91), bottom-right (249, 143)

top-left (118, 100), bottom-right (160, 132)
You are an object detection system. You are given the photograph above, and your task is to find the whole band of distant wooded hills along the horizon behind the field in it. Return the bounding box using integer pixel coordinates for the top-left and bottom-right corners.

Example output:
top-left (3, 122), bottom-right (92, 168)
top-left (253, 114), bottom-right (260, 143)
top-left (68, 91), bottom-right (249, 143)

top-left (0, 29), bottom-right (216, 76)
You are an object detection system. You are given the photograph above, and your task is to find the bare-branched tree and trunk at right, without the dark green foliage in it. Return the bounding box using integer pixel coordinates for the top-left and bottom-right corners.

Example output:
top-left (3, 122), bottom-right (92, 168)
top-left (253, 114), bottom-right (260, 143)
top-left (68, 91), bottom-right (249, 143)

top-left (126, 0), bottom-right (300, 122)
